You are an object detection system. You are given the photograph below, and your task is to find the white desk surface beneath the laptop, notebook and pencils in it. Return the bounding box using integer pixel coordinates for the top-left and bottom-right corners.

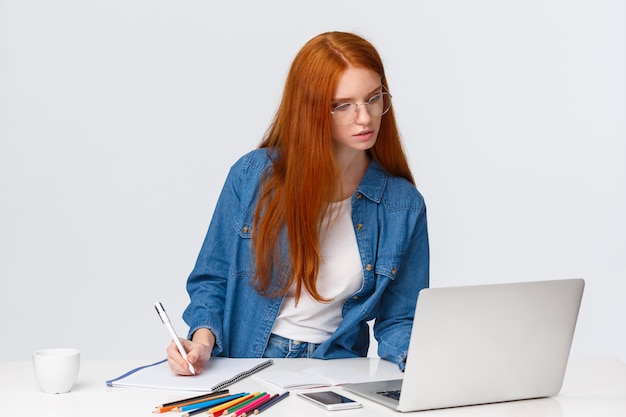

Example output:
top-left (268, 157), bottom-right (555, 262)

top-left (0, 358), bottom-right (626, 417)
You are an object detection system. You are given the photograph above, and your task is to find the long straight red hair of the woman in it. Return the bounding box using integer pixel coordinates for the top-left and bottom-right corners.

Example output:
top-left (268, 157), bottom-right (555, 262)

top-left (252, 32), bottom-right (414, 302)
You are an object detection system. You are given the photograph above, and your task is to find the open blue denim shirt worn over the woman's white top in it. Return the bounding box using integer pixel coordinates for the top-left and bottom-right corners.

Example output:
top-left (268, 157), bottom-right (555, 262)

top-left (183, 149), bottom-right (429, 369)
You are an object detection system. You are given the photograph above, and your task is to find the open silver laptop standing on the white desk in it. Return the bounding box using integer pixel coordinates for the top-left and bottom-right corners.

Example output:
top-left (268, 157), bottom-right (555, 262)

top-left (342, 279), bottom-right (585, 411)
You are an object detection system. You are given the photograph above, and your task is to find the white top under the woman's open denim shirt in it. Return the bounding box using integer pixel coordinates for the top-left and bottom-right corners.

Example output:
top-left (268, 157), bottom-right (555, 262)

top-left (272, 198), bottom-right (363, 343)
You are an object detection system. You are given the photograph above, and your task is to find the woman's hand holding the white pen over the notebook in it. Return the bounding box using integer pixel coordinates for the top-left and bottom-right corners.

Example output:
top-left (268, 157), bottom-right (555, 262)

top-left (167, 329), bottom-right (215, 375)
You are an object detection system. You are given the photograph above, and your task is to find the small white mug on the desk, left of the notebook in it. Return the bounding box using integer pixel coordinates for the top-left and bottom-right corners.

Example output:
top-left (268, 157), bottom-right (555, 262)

top-left (33, 348), bottom-right (80, 394)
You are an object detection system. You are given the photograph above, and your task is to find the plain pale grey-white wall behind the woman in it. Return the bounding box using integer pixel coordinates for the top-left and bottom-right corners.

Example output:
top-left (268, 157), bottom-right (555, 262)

top-left (0, 0), bottom-right (626, 361)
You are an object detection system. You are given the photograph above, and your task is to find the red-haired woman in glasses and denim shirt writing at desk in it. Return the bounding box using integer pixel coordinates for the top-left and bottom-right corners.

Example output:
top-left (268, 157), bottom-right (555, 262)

top-left (167, 32), bottom-right (429, 375)
